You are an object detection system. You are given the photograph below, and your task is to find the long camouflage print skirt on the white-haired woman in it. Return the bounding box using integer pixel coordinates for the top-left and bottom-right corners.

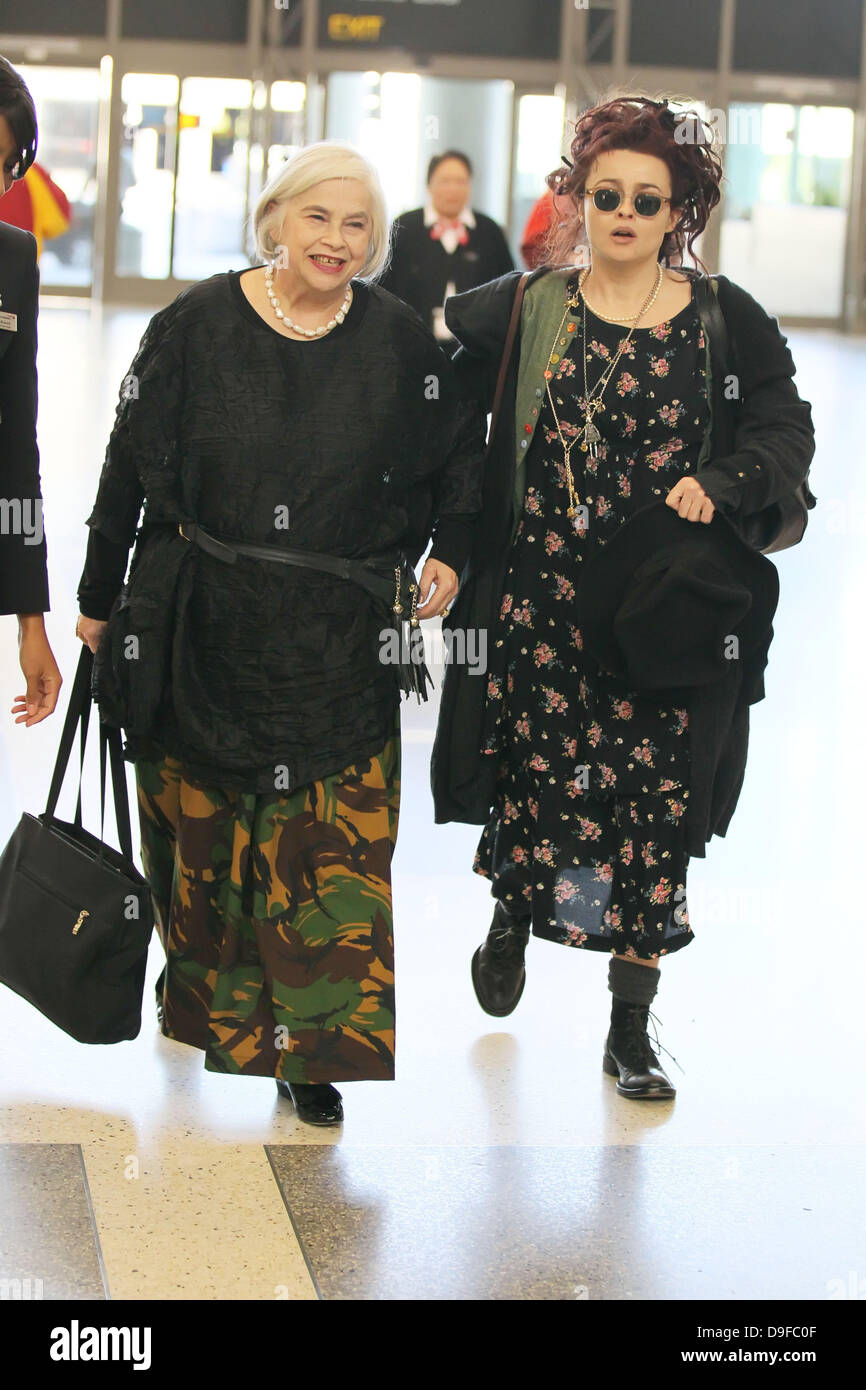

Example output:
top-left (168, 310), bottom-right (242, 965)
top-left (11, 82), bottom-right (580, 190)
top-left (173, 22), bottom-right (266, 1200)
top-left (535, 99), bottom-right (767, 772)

top-left (135, 710), bottom-right (400, 1081)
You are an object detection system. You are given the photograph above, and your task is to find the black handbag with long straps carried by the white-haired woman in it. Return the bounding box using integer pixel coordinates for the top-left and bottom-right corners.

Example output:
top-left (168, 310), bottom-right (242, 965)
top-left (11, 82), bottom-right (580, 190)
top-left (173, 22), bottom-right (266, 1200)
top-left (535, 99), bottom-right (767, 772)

top-left (0, 646), bottom-right (153, 1043)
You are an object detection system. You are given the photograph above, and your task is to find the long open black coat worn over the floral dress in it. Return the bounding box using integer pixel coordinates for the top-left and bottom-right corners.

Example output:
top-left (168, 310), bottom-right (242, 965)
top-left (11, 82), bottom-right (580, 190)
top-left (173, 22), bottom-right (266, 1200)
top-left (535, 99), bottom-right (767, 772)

top-left (431, 268), bottom-right (815, 858)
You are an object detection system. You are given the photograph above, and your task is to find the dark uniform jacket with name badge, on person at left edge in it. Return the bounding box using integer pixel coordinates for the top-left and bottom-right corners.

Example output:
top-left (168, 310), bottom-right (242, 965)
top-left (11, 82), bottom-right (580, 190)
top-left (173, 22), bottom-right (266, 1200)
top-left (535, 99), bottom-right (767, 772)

top-left (0, 222), bottom-right (49, 613)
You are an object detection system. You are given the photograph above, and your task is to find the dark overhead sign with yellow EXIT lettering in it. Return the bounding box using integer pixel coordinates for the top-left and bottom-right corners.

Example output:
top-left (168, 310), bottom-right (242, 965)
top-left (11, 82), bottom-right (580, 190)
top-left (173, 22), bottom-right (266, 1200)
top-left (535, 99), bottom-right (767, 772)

top-left (318, 0), bottom-right (562, 60)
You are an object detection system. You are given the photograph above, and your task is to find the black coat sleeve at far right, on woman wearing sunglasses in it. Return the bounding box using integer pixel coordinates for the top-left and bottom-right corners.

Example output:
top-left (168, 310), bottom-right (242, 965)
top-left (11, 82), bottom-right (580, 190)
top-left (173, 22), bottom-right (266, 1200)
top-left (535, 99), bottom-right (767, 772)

top-left (698, 275), bottom-right (815, 516)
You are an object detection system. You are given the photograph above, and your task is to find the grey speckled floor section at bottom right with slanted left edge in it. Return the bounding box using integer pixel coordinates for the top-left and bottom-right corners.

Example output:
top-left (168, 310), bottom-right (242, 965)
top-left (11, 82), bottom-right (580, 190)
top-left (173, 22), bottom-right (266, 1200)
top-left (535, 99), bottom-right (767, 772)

top-left (270, 1144), bottom-right (866, 1301)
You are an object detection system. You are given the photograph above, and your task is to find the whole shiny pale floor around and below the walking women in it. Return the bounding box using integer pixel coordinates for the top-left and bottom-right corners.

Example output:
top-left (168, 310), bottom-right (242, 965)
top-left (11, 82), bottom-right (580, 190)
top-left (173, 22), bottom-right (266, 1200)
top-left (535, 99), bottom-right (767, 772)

top-left (0, 298), bottom-right (866, 1300)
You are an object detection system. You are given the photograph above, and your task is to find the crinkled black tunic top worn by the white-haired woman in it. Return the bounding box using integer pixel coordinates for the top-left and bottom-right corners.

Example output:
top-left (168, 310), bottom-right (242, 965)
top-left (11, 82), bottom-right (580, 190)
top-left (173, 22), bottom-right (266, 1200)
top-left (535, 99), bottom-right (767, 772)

top-left (79, 272), bottom-right (484, 791)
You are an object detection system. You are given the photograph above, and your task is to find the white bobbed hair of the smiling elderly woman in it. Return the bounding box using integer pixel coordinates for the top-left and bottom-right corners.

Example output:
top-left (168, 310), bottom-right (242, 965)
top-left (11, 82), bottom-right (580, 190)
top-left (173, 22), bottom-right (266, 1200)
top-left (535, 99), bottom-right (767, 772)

top-left (253, 140), bottom-right (391, 279)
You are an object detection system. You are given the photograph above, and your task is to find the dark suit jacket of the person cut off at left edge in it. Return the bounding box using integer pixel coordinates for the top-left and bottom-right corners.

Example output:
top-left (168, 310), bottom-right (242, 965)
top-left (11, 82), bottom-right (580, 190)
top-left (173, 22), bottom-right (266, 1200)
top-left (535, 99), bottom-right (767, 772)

top-left (0, 236), bottom-right (50, 613)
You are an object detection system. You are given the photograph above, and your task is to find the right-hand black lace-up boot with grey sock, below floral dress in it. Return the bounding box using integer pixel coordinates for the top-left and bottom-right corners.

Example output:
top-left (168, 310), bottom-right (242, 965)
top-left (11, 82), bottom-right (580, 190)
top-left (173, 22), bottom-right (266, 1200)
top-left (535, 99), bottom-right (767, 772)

top-left (602, 956), bottom-right (677, 1101)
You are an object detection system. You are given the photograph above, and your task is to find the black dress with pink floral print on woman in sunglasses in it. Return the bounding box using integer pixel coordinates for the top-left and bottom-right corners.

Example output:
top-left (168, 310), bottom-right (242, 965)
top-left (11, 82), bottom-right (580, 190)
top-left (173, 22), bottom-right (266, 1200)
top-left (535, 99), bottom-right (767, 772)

top-left (473, 278), bottom-right (709, 959)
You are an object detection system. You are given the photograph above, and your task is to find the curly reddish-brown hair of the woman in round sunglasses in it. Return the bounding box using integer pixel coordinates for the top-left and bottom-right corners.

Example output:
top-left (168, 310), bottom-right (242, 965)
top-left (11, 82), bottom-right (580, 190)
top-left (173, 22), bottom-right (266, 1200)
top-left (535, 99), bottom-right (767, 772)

top-left (547, 96), bottom-right (723, 272)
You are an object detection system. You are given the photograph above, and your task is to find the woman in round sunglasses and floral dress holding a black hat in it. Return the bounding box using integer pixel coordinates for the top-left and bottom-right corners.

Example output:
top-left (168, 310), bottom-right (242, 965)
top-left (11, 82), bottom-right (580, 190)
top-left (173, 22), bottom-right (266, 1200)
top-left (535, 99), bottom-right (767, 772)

top-left (432, 97), bottom-right (815, 1099)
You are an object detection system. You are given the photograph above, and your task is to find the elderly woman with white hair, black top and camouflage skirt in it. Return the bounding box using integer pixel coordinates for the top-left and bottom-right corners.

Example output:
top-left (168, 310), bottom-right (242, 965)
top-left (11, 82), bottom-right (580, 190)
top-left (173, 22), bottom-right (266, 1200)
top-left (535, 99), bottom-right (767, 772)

top-left (78, 142), bottom-right (485, 1125)
